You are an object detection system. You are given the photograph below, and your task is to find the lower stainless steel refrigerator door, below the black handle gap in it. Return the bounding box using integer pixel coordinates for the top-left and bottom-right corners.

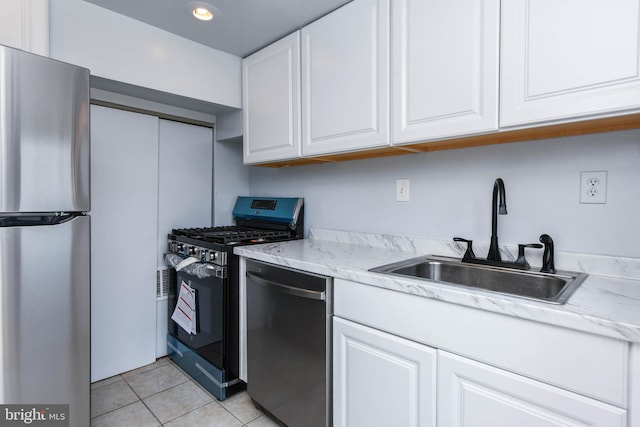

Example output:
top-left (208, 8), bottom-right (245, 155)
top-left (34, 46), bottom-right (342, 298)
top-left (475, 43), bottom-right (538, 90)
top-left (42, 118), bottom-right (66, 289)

top-left (0, 216), bottom-right (91, 427)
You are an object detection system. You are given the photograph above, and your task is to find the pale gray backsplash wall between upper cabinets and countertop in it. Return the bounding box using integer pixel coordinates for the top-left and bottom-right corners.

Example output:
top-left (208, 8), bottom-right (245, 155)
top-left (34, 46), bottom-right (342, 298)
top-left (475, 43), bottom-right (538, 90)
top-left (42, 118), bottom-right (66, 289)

top-left (249, 130), bottom-right (640, 257)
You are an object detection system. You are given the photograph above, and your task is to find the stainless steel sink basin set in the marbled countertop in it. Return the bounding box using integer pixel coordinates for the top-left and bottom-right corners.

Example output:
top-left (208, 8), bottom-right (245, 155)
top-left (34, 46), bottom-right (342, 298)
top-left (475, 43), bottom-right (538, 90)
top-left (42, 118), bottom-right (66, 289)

top-left (369, 256), bottom-right (587, 304)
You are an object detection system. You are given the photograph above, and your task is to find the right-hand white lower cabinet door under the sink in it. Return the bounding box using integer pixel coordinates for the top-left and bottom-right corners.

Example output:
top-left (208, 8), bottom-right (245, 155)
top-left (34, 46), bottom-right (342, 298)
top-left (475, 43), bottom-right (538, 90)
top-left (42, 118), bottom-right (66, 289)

top-left (438, 351), bottom-right (627, 427)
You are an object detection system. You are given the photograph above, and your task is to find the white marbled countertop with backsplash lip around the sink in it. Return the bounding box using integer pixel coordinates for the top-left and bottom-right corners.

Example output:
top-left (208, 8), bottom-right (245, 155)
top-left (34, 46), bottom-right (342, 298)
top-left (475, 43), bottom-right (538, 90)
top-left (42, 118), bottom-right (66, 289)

top-left (234, 229), bottom-right (640, 343)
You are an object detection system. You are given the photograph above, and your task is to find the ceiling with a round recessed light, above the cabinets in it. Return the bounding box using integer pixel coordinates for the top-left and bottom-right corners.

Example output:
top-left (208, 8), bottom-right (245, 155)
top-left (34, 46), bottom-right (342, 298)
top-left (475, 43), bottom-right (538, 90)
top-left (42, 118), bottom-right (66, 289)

top-left (85, 0), bottom-right (350, 58)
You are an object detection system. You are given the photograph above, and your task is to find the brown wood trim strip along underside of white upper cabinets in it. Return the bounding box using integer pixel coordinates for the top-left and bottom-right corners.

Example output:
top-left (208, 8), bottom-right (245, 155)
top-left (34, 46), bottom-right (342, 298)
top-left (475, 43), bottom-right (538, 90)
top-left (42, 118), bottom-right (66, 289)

top-left (255, 113), bottom-right (640, 168)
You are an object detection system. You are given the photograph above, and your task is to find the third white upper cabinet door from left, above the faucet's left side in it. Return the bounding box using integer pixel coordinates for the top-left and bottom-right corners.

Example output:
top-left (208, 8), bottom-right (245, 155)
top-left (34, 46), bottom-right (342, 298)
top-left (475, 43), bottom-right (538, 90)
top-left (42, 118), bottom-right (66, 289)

top-left (392, 0), bottom-right (500, 144)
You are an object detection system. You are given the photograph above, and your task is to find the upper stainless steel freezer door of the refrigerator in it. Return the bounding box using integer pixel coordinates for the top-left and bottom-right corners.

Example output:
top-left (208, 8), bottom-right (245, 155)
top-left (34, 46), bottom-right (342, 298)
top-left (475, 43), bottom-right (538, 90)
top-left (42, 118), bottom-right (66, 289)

top-left (0, 46), bottom-right (91, 214)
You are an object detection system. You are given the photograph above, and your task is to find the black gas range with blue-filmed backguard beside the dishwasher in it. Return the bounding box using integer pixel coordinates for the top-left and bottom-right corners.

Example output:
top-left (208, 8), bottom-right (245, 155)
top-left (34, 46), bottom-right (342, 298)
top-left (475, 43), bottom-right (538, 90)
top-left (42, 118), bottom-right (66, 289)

top-left (165, 197), bottom-right (304, 400)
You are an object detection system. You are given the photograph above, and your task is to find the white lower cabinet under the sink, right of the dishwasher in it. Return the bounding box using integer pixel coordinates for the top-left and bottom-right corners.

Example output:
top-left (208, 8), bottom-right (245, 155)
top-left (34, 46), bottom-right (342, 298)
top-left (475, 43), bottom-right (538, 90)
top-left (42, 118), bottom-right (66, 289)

top-left (333, 278), bottom-right (640, 427)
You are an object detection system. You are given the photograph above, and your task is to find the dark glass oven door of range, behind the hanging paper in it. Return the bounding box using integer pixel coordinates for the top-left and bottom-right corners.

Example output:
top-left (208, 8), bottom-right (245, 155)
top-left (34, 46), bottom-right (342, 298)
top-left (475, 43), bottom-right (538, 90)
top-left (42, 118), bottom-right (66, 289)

top-left (169, 270), bottom-right (228, 369)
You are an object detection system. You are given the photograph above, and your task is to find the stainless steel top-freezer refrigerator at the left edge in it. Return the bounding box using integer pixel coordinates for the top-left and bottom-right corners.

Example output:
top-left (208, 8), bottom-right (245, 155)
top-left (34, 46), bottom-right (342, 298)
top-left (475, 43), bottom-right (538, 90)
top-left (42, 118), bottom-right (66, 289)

top-left (0, 46), bottom-right (91, 427)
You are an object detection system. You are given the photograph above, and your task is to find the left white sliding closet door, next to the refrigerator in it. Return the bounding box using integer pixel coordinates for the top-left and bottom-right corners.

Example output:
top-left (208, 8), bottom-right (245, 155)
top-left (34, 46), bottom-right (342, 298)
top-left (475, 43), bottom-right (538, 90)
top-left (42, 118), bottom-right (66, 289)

top-left (91, 106), bottom-right (158, 381)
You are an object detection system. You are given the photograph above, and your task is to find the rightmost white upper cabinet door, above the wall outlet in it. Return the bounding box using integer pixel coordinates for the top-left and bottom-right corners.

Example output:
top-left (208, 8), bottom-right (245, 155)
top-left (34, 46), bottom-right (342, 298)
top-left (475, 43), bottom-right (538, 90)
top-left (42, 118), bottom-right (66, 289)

top-left (500, 0), bottom-right (640, 126)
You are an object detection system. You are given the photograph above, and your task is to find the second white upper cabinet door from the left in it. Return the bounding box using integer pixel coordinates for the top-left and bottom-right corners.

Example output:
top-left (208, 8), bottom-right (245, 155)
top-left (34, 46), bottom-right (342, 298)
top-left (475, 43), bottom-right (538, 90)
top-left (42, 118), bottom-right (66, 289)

top-left (302, 0), bottom-right (389, 156)
